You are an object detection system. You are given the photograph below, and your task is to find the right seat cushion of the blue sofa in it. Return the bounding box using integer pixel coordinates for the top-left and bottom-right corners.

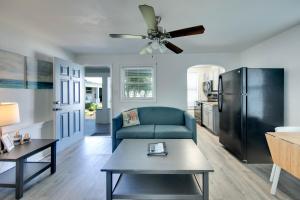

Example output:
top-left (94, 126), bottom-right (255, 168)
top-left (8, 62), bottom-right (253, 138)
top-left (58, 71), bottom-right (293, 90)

top-left (155, 125), bottom-right (193, 139)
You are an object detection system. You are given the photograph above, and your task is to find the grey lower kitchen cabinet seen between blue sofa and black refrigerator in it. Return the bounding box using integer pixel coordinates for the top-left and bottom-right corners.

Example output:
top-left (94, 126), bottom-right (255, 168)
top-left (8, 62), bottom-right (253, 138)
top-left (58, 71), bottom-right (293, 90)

top-left (202, 102), bottom-right (219, 135)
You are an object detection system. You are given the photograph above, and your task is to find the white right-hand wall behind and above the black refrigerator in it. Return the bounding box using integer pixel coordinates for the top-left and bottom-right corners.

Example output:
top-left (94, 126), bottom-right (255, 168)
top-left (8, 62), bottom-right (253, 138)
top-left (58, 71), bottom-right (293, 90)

top-left (241, 25), bottom-right (300, 126)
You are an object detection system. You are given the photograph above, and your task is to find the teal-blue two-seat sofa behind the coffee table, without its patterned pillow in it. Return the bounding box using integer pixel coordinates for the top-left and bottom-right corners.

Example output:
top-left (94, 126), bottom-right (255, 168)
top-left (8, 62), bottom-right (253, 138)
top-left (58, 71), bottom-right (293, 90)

top-left (112, 107), bottom-right (197, 151)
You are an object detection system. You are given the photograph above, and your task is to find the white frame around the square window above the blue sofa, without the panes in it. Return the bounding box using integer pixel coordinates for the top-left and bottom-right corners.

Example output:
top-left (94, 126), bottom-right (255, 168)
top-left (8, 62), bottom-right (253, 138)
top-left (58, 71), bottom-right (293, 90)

top-left (120, 65), bottom-right (156, 102)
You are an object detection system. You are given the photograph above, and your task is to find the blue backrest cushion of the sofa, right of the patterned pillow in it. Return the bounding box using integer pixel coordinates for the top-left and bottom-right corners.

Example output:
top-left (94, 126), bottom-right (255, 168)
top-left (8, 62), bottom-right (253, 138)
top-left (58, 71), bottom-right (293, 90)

top-left (138, 107), bottom-right (185, 125)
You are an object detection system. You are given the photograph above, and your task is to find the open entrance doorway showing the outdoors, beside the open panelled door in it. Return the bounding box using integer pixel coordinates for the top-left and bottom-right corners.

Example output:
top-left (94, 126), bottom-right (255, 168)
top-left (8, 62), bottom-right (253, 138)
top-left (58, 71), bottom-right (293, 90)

top-left (84, 66), bottom-right (111, 136)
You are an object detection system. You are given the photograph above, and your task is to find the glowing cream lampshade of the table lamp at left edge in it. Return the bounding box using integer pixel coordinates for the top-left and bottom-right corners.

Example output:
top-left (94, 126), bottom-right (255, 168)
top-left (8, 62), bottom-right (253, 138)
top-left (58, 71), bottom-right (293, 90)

top-left (0, 103), bottom-right (20, 127)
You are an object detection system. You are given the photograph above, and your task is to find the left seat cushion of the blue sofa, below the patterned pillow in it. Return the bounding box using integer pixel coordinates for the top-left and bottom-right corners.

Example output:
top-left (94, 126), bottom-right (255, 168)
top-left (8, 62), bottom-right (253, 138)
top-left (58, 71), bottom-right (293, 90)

top-left (116, 125), bottom-right (154, 139)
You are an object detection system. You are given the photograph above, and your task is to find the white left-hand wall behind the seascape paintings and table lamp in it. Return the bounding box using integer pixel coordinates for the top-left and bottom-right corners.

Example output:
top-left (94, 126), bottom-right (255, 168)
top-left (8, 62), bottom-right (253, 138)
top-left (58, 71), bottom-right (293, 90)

top-left (0, 22), bottom-right (74, 172)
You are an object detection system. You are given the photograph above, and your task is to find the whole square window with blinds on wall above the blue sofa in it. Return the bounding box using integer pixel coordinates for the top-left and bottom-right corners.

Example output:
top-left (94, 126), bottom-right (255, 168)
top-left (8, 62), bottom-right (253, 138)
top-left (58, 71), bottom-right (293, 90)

top-left (121, 67), bottom-right (155, 100)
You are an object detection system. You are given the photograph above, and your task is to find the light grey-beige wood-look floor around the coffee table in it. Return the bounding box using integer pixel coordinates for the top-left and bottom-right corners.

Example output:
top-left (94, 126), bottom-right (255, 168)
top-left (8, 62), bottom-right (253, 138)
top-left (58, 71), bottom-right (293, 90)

top-left (0, 126), bottom-right (300, 200)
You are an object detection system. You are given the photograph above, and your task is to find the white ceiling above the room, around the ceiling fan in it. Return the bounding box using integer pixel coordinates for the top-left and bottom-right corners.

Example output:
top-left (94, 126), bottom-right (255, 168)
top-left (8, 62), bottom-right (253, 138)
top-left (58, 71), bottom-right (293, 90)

top-left (0, 0), bottom-right (300, 54)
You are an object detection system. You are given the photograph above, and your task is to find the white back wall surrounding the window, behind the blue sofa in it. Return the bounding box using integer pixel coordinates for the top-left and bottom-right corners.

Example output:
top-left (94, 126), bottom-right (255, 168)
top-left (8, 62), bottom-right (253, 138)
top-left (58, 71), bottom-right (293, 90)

top-left (75, 53), bottom-right (240, 115)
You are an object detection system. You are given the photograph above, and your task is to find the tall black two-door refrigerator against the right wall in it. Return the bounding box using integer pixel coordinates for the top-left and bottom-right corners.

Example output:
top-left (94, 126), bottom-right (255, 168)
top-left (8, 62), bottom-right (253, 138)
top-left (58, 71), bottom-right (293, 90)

top-left (218, 67), bottom-right (284, 163)
